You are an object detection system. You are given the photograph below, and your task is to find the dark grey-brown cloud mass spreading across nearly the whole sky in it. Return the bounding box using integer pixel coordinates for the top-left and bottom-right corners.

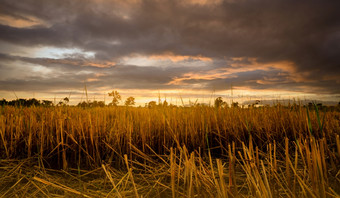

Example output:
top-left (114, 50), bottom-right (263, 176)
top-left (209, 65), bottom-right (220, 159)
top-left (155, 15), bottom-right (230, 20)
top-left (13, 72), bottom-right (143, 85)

top-left (0, 0), bottom-right (340, 98)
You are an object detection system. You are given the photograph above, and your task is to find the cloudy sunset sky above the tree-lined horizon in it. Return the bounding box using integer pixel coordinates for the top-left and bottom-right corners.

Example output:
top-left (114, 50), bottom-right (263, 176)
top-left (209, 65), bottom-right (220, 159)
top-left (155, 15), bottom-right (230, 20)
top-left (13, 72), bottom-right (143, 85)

top-left (0, 0), bottom-right (340, 104)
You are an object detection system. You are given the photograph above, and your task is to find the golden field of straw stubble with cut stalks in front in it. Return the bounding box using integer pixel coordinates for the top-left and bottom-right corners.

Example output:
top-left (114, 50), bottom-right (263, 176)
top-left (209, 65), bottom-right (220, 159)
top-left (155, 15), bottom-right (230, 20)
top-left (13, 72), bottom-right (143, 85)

top-left (0, 105), bottom-right (340, 197)
